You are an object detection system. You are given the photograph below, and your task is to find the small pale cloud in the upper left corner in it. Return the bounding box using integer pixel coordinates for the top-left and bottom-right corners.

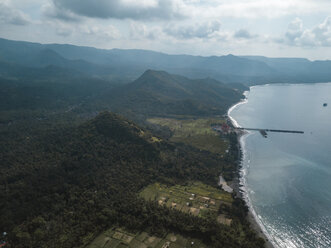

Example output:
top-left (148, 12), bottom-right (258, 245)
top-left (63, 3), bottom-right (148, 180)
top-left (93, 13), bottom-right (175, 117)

top-left (0, 3), bottom-right (30, 25)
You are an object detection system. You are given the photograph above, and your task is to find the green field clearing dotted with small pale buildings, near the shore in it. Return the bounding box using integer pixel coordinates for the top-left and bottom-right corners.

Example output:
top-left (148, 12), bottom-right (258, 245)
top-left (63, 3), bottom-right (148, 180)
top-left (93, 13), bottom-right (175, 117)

top-left (140, 182), bottom-right (233, 217)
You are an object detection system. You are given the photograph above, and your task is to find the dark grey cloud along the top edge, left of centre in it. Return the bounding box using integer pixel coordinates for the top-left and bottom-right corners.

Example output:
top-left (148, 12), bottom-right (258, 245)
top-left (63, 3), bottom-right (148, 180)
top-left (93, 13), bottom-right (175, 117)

top-left (53, 0), bottom-right (187, 20)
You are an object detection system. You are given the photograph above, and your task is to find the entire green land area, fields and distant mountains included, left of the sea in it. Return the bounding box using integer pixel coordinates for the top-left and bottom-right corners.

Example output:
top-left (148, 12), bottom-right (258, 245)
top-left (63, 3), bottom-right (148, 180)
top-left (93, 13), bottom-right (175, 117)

top-left (0, 35), bottom-right (331, 248)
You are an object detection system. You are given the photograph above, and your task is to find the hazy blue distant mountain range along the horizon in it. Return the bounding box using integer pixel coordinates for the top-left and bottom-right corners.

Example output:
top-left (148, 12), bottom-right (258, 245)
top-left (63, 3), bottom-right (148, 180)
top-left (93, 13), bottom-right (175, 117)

top-left (0, 39), bottom-right (331, 85)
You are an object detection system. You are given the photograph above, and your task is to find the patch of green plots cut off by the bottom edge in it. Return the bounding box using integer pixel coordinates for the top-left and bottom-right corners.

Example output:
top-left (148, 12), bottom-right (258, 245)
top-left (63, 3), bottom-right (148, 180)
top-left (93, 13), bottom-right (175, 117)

top-left (86, 228), bottom-right (206, 248)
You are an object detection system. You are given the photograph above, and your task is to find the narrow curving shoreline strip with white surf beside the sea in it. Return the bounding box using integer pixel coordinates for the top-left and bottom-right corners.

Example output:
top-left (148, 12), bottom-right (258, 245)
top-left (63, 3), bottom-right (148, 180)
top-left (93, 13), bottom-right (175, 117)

top-left (227, 90), bottom-right (275, 248)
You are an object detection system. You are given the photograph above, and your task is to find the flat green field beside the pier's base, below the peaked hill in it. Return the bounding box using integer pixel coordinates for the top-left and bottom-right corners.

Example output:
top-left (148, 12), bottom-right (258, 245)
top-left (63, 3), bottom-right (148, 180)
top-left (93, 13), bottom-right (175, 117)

top-left (148, 118), bottom-right (229, 154)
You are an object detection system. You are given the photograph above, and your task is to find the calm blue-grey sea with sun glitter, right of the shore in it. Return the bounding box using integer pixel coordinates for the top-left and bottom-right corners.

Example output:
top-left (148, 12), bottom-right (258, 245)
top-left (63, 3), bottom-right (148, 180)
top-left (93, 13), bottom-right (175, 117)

top-left (229, 83), bottom-right (331, 248)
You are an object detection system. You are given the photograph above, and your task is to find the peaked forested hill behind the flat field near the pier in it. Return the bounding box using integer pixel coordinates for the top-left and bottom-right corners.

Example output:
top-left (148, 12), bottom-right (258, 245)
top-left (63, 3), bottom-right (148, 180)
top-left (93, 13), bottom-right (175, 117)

top-left (102, 70), bottom-right (242, 116)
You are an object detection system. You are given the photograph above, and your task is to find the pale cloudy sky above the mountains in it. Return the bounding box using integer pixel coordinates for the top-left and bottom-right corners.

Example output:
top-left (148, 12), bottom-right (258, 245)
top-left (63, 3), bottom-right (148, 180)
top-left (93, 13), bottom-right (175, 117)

top-left (0, 0), bottom-right (331, 60)
